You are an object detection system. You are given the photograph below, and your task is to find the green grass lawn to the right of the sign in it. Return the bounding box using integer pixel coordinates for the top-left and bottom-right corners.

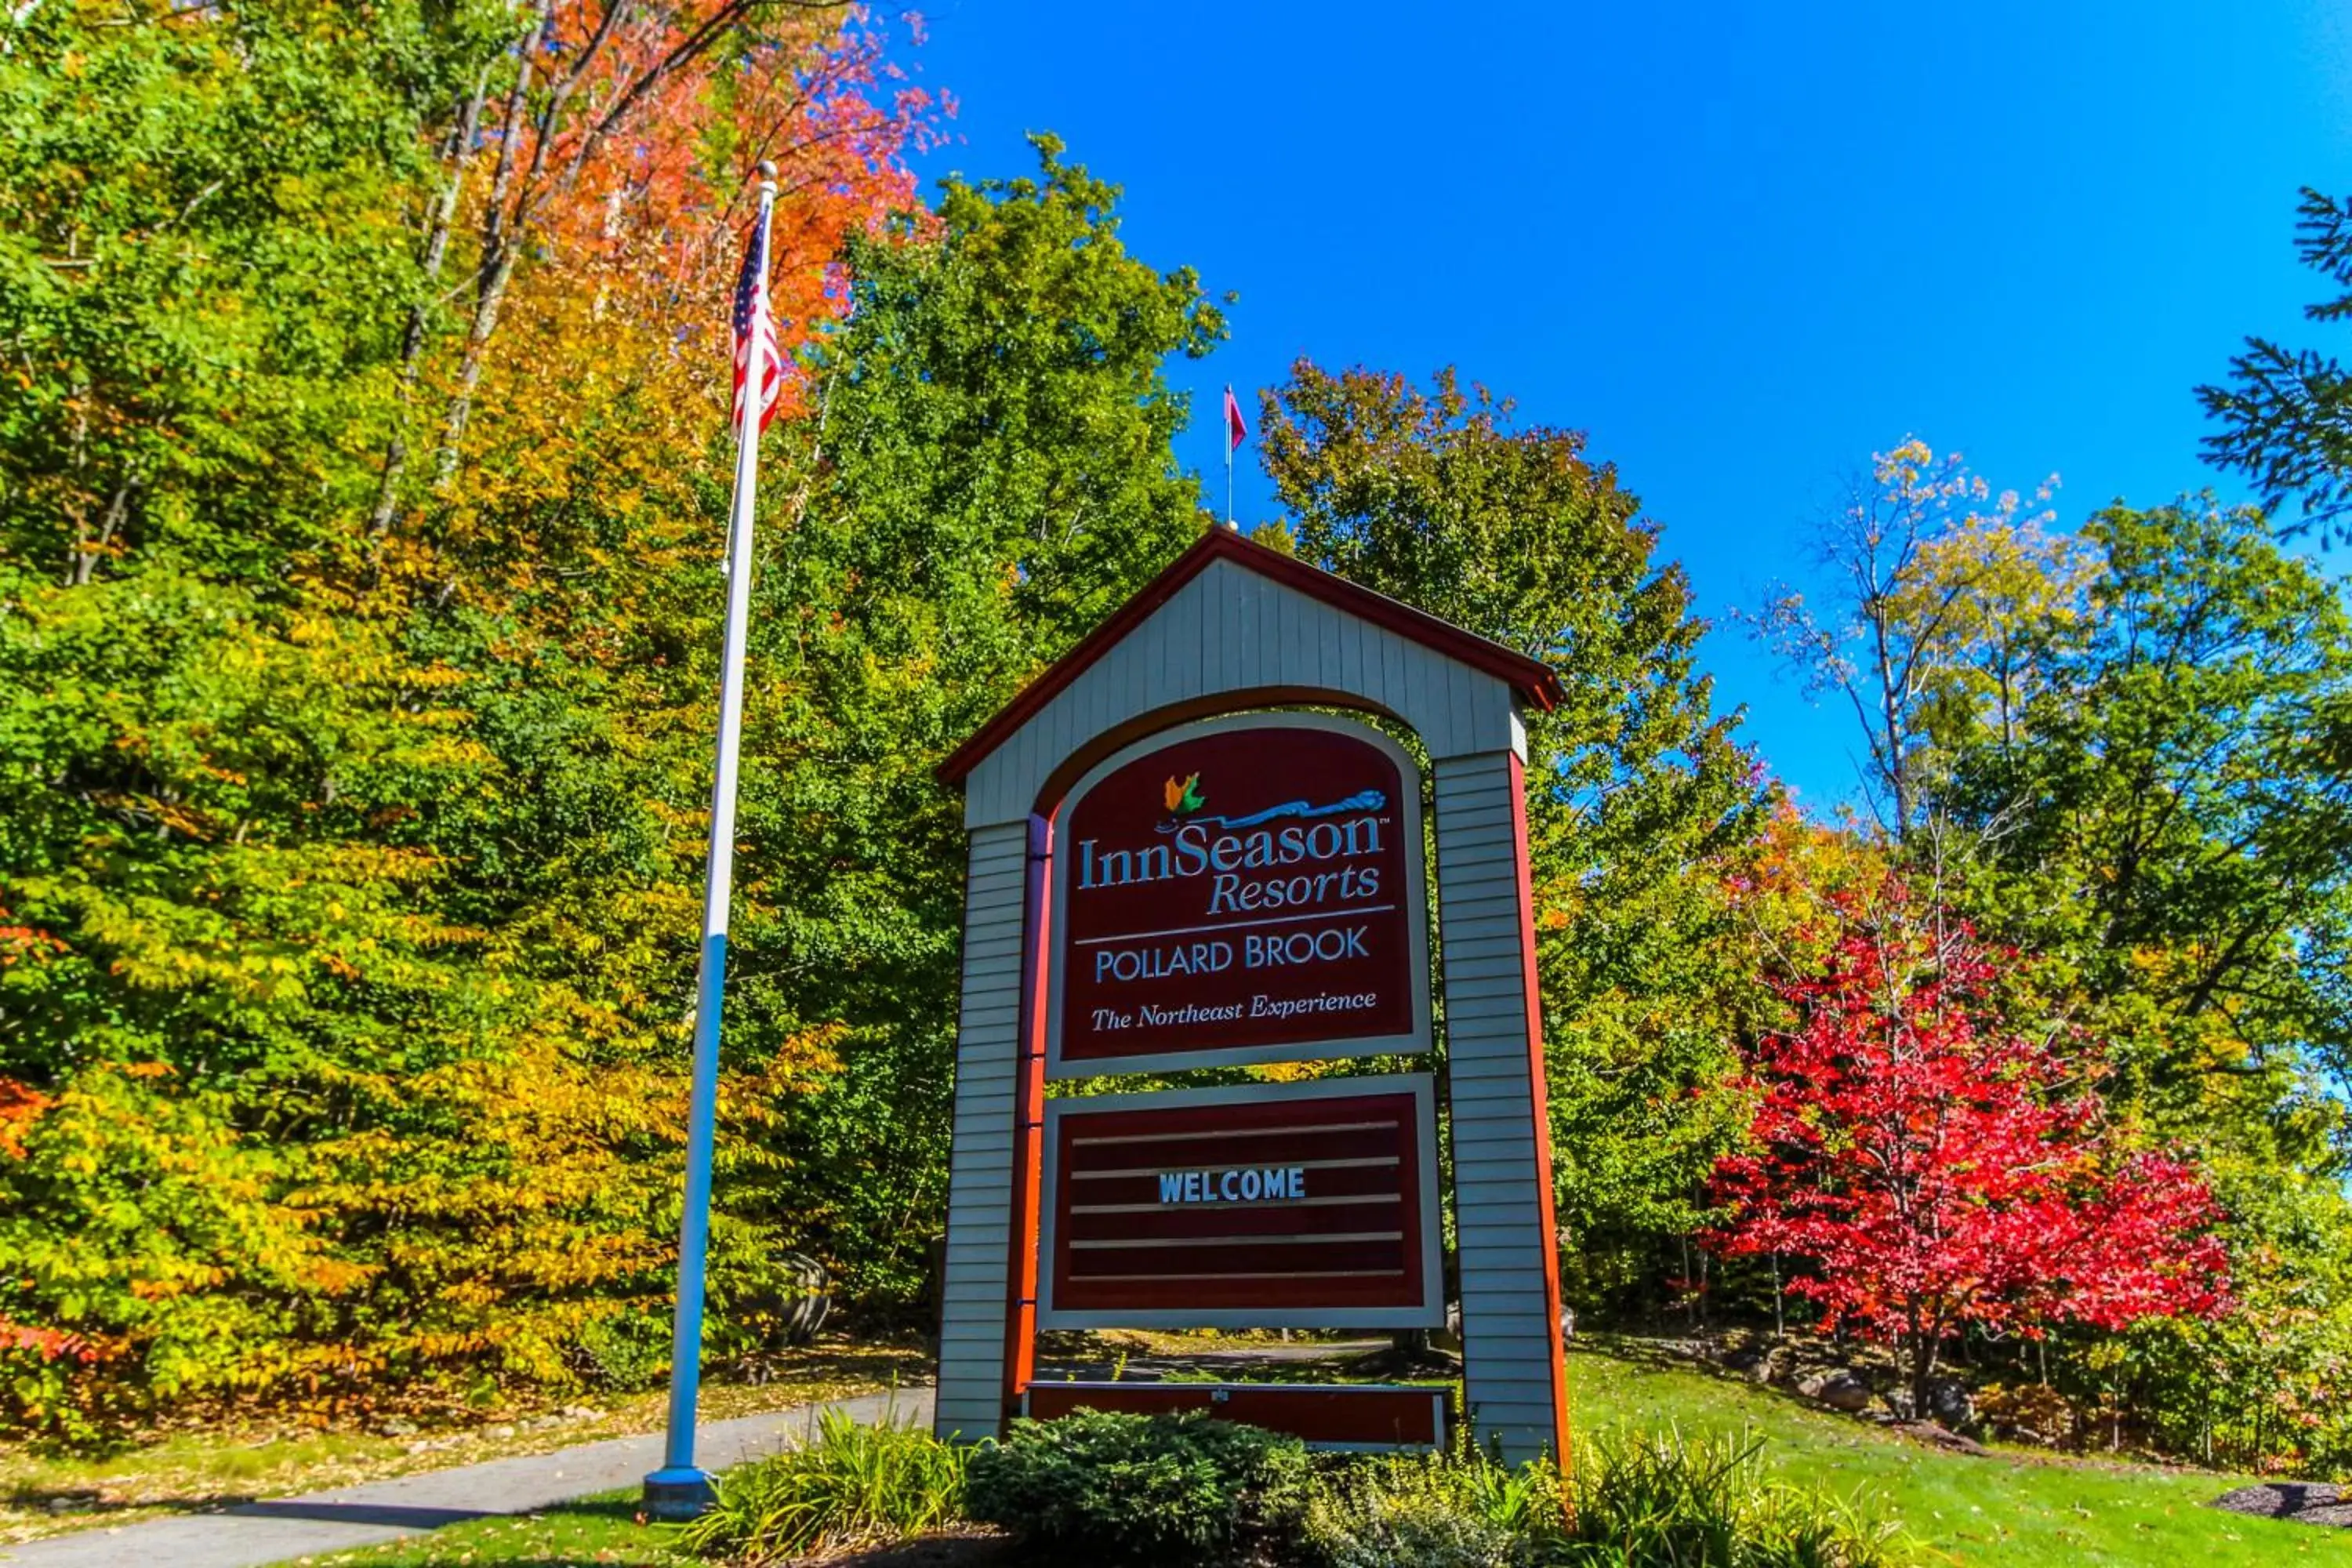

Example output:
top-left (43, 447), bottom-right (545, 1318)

top-left (1569, 1352), bottom-right (2352, 1568)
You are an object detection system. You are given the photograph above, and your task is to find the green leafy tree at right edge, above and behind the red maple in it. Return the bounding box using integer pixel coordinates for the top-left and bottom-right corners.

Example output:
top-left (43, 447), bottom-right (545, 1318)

top-left (1950, 499), bottom-right (2352, 1161)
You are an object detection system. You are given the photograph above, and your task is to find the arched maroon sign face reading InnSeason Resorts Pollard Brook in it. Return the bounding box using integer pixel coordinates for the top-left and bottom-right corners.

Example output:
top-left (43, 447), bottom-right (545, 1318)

top-left (1047, 715), bottom-right (1430, 1076)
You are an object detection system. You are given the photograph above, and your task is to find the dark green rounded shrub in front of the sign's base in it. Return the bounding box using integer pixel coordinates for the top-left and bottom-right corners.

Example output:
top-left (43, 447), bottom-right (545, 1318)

top-left (964, 1410), bottom-right (1308, 1568)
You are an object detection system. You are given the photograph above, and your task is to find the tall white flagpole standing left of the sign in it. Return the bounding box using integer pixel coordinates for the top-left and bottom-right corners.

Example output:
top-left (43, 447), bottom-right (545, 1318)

top-left (644, 162), bottom-right (776, 1519)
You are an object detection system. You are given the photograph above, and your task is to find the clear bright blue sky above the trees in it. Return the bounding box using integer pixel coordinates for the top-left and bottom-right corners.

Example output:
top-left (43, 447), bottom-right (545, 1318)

top-left (889, 0), bottom-right (2352, 806)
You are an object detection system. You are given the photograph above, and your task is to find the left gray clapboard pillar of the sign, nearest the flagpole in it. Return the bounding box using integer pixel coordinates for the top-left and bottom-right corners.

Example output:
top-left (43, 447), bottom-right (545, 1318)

top-left (934, 820), bottom-right (1028, 1439)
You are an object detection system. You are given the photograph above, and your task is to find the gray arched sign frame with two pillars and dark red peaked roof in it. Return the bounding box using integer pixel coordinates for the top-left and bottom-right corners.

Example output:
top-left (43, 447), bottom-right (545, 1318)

top-left (934, 529), bottom-right (1569, 1465)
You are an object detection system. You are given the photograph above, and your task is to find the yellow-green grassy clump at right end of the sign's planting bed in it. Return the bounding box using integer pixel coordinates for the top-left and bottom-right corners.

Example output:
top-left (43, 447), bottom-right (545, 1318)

top-left (1545, 1432), bottom-right (1896, 1568)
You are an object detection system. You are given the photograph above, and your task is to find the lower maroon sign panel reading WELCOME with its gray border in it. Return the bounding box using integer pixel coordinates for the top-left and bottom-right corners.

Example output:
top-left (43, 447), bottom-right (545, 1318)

top-left (1037, 1074), bottom-right (1444, 1328)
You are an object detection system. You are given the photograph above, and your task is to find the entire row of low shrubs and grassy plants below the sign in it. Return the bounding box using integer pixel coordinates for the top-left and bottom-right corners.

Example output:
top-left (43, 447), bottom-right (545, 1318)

top-left (659, 1410), bottom-right (1896, 1568)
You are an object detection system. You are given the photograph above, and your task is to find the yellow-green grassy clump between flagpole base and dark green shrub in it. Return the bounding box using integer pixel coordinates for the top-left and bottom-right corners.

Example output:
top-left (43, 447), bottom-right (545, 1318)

top-left (677, 1410), bottom-right (964, 1563)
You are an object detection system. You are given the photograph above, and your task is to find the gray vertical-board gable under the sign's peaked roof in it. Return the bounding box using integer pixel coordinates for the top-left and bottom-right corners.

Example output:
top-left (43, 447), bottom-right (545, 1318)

top-left (964, 562), bottom-right (1517, 827)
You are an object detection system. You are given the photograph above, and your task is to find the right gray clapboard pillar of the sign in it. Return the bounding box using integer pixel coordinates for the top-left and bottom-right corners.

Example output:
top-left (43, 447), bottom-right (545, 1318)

top-left (1435, 750), bottom-right (1559, 1462)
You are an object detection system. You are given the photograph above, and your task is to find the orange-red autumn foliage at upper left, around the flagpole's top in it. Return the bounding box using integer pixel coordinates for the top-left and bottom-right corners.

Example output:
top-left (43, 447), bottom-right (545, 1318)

top-left (459, 0), bottom-right (948, 535)
